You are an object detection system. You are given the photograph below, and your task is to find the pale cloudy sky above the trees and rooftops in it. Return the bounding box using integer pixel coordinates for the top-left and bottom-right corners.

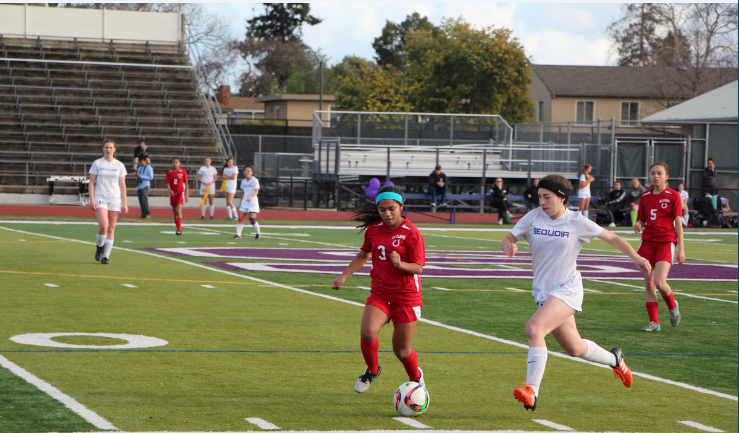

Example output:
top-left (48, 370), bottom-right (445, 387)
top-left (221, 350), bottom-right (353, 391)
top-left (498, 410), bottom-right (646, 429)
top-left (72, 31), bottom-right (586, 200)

top-left (206, 2), bottom-right (621, 89)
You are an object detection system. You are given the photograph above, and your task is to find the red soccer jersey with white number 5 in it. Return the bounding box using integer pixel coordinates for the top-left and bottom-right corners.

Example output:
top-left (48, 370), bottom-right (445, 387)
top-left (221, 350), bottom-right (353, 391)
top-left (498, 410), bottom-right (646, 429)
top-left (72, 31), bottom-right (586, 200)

top-left (639, 188), bottom-right (683, 243)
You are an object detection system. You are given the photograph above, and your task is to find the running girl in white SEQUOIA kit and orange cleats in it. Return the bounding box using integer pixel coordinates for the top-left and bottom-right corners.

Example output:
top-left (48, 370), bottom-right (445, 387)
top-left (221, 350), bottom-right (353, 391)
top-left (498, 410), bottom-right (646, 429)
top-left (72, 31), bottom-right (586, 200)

top-left (502, 175), bottom-right (650, 411)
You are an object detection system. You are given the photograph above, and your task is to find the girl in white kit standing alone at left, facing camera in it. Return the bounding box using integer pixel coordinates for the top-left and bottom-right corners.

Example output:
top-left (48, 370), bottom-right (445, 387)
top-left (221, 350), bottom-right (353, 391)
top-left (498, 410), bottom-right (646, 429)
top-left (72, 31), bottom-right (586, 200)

top-left (90, 140), bottom-right (128, 265)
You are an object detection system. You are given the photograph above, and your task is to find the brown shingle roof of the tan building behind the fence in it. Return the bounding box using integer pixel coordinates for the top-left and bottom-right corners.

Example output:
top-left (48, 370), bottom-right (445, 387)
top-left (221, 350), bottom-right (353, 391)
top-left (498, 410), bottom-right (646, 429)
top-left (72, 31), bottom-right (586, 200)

top-left (532, 65), bottom-right (737, 99)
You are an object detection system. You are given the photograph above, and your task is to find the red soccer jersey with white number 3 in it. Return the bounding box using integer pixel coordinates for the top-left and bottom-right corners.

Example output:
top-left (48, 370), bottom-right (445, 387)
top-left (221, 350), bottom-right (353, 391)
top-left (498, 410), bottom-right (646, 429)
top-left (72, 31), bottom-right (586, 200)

top-left (362, 218), bottom-right (426, 306)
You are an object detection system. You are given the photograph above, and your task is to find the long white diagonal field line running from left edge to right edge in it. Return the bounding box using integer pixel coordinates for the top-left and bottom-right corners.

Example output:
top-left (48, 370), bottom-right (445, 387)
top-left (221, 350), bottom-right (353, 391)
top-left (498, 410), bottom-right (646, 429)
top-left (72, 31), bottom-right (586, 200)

top-left (0, 226), bottom-right (739, 401)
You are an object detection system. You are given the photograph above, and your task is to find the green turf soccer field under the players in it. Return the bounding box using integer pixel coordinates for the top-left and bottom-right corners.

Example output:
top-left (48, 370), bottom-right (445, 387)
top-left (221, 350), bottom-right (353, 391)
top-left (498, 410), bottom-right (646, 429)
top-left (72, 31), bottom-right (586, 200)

top-left (0, 219), bottom-right (738, 432)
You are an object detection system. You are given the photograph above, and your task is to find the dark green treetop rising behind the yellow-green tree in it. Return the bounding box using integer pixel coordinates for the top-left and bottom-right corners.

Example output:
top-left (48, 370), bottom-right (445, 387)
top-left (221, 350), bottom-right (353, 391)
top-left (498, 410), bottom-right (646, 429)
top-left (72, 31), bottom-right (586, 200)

top-left (372, 12), bottom-right (437, 71)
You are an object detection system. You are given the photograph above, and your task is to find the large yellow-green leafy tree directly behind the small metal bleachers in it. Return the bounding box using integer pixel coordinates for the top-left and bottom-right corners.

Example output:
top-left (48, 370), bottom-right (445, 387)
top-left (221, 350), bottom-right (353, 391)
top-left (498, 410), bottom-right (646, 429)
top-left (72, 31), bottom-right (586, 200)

top-left (405, 19), bottom-right (534, 123)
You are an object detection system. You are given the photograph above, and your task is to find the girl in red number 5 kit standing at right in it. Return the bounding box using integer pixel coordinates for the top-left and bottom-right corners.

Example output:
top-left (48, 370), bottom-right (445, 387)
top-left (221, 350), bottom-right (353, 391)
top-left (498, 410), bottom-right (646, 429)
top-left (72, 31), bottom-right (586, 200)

top-left (634, 162), bottom-right (685, 332)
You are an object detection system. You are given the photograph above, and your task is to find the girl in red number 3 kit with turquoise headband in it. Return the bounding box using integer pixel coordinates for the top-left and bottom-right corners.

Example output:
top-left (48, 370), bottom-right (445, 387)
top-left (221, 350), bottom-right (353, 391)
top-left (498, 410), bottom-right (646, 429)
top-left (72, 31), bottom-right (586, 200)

top-left (331, 187), bottom-right (426, 392)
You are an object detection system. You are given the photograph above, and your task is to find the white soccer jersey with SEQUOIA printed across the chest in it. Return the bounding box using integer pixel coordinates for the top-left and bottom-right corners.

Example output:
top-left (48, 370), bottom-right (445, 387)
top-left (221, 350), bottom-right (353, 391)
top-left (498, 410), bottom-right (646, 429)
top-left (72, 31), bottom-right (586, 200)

top-left (511, 208), bottom-right (603, 311)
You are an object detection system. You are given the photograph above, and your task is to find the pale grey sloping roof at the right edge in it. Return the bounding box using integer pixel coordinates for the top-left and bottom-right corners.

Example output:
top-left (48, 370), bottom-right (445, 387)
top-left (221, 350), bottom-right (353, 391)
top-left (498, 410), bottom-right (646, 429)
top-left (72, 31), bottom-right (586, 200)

top-left (644, 81), bottom-right (739, 122)
